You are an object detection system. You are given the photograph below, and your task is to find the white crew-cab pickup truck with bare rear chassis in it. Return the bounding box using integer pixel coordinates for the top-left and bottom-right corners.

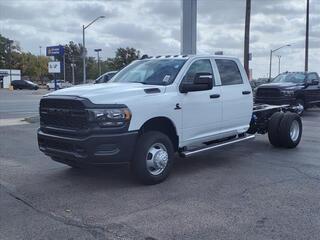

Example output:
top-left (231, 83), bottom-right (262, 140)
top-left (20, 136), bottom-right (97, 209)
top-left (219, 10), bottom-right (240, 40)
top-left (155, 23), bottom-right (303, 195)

top-left (38, 55), bottom-right (302, 184)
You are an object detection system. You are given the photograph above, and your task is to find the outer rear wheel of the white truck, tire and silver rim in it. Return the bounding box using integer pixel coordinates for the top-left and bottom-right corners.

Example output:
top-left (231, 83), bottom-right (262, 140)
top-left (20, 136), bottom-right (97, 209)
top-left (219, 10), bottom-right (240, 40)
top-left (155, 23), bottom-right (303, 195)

top-left (280, 112), bottom-right (302, 148)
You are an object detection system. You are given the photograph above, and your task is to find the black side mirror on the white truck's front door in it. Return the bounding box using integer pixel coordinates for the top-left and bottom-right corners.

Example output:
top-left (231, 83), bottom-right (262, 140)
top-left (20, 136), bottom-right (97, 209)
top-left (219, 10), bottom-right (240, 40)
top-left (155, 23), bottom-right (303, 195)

top-left (180, 73), bottom-right (212, 93)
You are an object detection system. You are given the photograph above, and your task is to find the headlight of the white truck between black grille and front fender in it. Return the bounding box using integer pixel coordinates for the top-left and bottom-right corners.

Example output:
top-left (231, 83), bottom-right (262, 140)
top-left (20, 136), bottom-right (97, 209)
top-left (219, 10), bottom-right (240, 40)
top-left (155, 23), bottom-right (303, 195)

top-left (89, 108), bottom-right (131, 127)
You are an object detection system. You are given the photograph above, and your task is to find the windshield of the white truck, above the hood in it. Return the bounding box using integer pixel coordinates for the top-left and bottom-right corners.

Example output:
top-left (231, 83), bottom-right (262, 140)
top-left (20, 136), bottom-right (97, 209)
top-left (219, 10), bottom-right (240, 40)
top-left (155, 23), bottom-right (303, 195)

top-left (110, 59), bottom-right (186, 85)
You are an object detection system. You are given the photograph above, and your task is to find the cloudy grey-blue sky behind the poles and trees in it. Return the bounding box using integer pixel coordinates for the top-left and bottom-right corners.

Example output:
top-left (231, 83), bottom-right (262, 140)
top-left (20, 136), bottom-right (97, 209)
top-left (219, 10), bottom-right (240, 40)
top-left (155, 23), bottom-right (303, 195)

top-left (0, 0), bottom-right (320, 78)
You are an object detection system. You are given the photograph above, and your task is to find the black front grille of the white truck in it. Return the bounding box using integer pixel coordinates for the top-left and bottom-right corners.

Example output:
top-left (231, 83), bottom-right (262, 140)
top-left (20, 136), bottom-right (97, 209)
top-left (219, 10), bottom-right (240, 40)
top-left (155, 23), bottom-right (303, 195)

top-left (40, 99), bottom-right (88, 130)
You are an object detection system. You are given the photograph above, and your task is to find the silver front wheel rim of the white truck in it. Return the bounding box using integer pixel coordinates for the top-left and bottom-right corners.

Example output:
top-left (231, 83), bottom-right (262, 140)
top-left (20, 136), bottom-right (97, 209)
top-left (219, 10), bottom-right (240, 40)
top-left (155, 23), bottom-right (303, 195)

top-left (146, 143), bottom-right (169, 175)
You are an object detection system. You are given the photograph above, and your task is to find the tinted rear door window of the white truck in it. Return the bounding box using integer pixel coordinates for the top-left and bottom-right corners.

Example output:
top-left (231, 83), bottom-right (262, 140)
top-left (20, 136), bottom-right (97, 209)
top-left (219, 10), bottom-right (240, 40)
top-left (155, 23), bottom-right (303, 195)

top-left (216, 59), bottom-right (243, 85)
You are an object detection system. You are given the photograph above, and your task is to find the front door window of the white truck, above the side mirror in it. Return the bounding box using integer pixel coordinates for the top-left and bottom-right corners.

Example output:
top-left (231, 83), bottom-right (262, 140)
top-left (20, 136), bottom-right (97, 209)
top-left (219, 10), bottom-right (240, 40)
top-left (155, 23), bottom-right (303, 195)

top-left (182, 59), bottom-right (214, 83)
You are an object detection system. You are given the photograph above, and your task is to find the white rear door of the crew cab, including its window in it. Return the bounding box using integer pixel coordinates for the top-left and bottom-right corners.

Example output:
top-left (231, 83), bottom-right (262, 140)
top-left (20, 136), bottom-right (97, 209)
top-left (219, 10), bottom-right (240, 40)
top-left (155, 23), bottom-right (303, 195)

top-left (215, 58), bottom-right (253, 133)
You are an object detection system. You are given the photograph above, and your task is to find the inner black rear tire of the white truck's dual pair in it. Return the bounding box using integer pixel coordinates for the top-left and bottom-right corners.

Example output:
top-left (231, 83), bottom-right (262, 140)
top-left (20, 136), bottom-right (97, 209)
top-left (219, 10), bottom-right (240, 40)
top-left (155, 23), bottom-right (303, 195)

top-left (268, 112), bottom-right (284, 147)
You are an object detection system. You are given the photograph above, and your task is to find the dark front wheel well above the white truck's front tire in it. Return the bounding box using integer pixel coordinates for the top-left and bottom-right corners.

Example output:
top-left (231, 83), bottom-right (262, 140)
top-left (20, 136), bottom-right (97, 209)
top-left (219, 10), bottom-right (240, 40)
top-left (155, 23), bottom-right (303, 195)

top-left (139, 117), bottom-right (179, 150)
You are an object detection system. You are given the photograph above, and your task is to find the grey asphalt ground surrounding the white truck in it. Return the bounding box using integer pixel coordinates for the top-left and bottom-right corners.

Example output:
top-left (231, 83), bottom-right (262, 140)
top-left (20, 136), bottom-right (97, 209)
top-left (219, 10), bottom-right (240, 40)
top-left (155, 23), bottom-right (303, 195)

top-left (0, 90), bottom-right (320, 240)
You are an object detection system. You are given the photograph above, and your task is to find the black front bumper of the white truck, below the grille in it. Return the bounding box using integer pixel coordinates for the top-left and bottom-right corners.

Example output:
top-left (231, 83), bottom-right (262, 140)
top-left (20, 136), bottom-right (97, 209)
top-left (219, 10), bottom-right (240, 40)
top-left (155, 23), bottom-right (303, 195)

top-left (38, 129), bottom-right (138, 165)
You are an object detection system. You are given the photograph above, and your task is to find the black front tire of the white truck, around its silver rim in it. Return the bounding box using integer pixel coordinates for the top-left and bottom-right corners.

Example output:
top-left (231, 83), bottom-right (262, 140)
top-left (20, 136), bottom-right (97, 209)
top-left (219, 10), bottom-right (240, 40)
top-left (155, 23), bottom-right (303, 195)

top-left (131, 131), bottom-right (174, 185)
